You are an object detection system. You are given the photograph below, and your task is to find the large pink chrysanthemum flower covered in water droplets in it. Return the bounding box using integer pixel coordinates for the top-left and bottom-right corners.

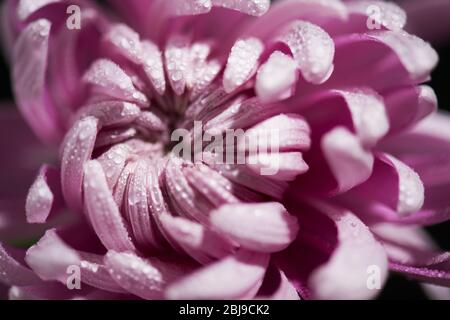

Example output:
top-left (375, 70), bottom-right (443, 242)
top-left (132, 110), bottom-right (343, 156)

top-left (0, 0), bottom-right (450, 299)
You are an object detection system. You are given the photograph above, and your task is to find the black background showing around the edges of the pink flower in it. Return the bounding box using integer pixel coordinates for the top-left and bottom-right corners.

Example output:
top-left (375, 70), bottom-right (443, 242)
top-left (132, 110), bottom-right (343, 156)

top-left (0, 10), bottom-right (450, 299)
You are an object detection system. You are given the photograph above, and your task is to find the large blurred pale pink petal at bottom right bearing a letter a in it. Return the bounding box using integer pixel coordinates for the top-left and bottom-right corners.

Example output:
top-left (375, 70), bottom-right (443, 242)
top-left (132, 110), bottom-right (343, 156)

top-left (309, 205), bottom-right (387, 299)
